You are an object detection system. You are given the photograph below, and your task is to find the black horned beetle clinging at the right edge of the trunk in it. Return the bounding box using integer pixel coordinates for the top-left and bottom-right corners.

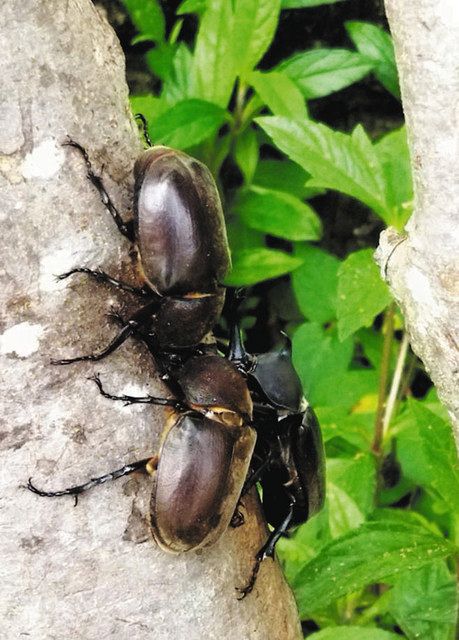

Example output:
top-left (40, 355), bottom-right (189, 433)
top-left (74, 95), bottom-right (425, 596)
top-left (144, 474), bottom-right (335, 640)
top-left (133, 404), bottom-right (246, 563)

top-left (228, 304), bottom-right (325, 599)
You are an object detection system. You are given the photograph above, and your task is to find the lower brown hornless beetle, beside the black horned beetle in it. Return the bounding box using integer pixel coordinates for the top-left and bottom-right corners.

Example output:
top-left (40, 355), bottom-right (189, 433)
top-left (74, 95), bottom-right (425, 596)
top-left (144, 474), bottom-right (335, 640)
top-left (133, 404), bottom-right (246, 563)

top-left (28, 352), bottom-right (256, 553)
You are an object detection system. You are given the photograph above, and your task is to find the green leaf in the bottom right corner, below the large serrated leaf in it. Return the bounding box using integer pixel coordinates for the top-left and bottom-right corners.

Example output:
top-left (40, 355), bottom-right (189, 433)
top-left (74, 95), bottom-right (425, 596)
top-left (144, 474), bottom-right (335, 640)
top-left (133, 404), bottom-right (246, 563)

top-left (389, 562), bottom-right (457, 640)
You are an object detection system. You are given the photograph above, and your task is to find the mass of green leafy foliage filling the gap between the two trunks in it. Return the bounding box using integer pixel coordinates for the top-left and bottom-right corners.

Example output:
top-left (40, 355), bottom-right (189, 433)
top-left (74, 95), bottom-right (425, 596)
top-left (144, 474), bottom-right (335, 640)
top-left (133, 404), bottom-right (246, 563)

top-left (124, 0), bottom-right (459, 640)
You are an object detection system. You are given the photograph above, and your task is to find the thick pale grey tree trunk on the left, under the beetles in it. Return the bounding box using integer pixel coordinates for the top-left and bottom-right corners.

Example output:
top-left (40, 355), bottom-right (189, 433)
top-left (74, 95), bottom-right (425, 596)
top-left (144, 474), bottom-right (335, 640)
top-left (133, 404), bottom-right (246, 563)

top-left (0, 0), bottom-right (301, 640)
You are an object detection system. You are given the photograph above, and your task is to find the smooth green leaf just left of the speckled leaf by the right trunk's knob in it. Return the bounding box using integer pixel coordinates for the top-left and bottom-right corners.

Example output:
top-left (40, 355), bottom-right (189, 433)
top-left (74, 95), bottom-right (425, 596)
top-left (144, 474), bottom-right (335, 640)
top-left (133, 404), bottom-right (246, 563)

top-left (292, 244), bottom-right (339, 323)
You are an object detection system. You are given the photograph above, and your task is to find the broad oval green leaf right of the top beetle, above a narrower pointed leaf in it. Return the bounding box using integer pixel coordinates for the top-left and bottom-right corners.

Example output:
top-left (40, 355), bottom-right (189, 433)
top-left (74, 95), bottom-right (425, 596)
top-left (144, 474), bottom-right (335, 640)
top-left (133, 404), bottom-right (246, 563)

top-left (232, 186), bottom-right (321, 244)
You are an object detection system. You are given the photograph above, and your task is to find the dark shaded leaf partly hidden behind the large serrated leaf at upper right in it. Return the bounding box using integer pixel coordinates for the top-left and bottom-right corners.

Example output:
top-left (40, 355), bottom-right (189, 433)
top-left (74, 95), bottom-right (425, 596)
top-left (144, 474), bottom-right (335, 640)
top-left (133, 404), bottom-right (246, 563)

top-left (253, 160), bottom-right (320, 200)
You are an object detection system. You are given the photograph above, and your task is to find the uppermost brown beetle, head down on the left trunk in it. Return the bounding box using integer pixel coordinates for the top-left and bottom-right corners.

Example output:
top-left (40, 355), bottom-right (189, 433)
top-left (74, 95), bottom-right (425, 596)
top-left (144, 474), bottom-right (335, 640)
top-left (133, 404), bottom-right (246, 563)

top-left (53, 134), bottom-right (231, 364)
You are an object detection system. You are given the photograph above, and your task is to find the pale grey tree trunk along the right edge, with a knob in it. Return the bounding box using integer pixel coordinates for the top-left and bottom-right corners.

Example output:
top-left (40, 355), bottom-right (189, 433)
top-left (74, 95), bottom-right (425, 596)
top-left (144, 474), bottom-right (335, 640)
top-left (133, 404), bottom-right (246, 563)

top-left (376, 0), bottom-right (459, 449)
